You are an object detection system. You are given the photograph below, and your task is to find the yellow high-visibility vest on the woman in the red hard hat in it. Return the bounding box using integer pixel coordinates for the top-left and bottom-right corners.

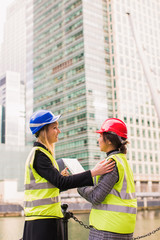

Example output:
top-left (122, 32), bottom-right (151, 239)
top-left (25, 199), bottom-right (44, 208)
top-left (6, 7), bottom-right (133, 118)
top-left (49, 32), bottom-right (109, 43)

top-left (89, 153), bottom-right (137, 234)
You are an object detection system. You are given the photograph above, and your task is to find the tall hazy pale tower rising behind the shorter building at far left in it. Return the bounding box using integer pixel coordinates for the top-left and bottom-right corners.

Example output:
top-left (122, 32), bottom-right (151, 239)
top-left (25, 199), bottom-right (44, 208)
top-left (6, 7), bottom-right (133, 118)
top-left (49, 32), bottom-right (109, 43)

top-left (0, 0), bottom-right (26, 83)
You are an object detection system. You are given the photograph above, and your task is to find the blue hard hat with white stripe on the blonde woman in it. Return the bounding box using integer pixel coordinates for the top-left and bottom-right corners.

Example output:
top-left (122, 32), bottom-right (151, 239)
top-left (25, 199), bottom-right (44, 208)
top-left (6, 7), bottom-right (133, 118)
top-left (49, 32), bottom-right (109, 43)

top-left (29, 110), bottom-right (61, 134)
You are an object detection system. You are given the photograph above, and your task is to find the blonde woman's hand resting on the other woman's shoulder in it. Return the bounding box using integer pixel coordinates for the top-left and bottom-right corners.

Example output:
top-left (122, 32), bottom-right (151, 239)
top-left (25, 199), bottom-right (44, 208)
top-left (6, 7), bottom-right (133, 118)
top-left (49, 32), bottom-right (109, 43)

top-left (91, 159), bottom-right (115, 177)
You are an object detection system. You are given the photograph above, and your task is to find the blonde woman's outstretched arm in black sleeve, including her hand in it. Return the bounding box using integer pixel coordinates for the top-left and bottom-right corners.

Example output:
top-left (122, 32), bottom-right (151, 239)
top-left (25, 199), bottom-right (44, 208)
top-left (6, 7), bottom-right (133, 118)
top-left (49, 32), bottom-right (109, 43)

top-left (33, 151), bottom-right (114, 191)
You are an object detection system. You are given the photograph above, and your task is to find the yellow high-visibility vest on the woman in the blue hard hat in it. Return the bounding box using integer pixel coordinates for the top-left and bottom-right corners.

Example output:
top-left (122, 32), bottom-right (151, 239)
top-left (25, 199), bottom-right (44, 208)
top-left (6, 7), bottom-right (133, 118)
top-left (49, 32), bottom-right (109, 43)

top-left (24, 147), bottom-right (63, 220)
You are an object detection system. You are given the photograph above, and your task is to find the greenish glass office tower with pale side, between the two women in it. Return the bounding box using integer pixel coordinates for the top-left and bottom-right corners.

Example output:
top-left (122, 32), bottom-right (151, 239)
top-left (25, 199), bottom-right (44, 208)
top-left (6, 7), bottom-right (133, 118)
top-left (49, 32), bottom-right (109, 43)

top-left (34, 0), bottom-right (108, 167)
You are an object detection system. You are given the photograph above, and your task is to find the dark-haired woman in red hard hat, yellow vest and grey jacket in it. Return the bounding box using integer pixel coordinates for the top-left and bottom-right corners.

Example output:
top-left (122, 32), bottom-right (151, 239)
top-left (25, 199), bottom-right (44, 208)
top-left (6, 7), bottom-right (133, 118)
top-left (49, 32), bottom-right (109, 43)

top-left (78, 118), bottom-right (137, 240)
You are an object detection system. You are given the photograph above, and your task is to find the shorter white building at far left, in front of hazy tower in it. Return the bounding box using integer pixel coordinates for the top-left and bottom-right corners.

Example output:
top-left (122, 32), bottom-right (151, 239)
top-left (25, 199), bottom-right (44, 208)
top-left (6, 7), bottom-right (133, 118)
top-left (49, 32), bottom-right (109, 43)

top-left (0, 71), bottom-right (25, 146)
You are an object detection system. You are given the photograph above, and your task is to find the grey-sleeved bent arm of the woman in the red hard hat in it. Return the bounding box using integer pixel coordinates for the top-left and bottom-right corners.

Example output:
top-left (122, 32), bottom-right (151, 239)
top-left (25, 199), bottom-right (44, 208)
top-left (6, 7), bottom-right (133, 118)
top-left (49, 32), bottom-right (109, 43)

top-left (78, 165), bottom-right (119, 204)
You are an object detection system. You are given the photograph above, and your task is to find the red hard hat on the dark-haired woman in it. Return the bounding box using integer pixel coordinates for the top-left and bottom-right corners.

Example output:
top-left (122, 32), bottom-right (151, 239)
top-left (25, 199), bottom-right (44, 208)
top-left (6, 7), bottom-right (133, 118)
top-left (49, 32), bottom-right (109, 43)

top-left (96, 118), bottom-right (127, 138)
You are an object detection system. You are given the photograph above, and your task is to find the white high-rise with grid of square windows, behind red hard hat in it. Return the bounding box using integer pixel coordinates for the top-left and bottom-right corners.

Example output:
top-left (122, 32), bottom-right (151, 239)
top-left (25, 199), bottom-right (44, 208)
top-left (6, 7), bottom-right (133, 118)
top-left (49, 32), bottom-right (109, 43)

top-left (107, 0), bottom-right (160, 191)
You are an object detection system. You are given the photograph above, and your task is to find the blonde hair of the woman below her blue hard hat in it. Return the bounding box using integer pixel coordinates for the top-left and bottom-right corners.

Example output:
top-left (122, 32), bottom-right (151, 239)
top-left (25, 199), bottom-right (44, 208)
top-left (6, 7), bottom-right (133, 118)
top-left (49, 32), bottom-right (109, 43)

top-left (37, 125), bottom-right (54, 155)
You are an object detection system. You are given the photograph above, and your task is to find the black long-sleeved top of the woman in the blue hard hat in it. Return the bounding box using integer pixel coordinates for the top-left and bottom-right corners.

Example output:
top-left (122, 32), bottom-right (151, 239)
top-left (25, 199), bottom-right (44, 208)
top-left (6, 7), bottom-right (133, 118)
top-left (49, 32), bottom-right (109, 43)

top-left (33, 142), bottom-right (93, 191)
